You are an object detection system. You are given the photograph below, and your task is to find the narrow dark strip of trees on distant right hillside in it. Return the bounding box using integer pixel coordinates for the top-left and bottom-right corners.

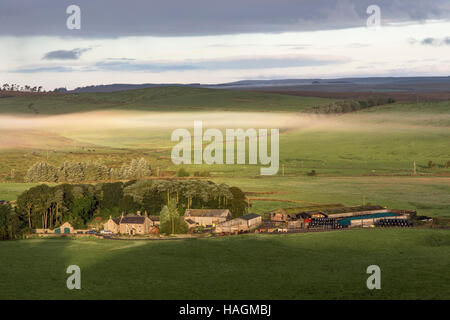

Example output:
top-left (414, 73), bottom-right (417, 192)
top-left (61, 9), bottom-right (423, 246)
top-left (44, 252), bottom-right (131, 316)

top-left (308, 97), bottom-right (395, 114)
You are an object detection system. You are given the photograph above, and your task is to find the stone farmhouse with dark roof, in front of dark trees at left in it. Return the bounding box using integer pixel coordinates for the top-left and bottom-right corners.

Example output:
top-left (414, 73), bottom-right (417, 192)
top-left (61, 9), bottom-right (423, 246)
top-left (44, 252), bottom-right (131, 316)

top-left (103, 214), bottom-right (159, 235)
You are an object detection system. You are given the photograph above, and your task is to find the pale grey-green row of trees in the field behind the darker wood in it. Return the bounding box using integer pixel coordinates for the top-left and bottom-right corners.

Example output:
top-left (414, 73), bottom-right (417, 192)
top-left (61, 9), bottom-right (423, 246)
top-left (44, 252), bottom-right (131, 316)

top-left (25, 158), bottom-right (152, 183)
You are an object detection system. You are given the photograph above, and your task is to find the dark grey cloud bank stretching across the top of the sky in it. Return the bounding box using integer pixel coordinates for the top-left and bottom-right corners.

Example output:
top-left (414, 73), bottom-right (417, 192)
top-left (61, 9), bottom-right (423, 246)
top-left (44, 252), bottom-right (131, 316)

top-left (0, 0), bottom-right (450, 37)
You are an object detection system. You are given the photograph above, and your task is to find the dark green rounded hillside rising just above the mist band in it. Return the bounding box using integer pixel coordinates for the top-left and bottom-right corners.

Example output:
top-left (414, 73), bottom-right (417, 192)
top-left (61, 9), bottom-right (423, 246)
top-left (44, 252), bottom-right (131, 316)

top-left (0, 87), bottom-right (334, 115)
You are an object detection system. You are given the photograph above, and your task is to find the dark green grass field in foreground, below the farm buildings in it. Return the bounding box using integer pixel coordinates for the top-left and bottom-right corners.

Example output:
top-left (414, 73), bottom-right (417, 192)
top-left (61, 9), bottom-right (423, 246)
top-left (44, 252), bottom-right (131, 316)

top-left (0, 229), bottom-right (450, 299)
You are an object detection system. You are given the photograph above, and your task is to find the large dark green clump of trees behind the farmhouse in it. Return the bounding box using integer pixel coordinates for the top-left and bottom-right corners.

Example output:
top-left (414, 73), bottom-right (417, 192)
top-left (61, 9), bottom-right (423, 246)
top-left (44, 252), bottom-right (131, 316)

top-left (10, 180), bottom-right (247, 234)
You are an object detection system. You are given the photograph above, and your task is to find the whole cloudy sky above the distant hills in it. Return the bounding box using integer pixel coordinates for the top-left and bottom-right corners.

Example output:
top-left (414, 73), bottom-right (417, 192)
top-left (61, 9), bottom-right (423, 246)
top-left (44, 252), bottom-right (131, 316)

top-left (0, 0), bottom-right (450, 90)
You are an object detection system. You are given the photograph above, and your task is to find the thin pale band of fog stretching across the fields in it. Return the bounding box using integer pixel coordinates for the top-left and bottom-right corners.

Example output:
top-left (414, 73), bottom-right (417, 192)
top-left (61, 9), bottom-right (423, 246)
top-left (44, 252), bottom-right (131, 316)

top-left (0, 111), bottom-right (450, 131)
